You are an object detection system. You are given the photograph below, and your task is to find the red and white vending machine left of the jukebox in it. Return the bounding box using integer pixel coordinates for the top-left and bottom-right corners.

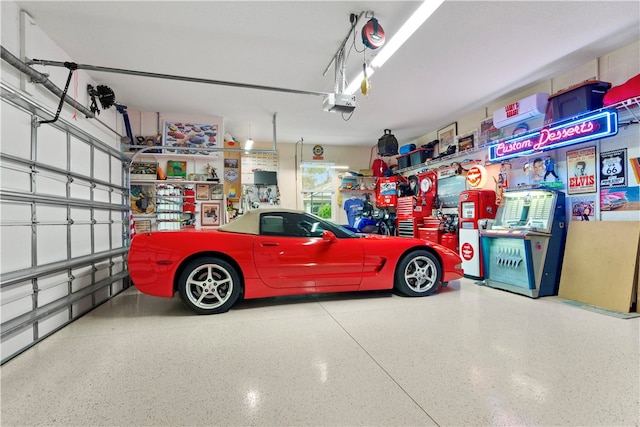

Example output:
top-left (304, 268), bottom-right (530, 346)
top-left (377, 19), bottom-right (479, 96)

top-left (458, 190), bottom-right (498, 280)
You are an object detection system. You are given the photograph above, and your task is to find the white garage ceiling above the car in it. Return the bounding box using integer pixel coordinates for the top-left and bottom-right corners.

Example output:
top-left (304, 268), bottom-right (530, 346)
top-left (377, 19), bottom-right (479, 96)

top-left (11, 0), bottom-right (640, 145)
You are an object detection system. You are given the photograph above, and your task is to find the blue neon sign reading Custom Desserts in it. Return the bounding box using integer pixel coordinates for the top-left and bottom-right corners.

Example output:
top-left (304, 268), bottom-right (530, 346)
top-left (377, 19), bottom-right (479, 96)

top-left (489, 110), bottom-right (618, 161)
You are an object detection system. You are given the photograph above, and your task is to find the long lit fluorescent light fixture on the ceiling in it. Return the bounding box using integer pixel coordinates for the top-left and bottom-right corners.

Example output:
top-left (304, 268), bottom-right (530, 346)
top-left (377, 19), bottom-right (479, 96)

top-left (346, 0), bottom-right (444, 94)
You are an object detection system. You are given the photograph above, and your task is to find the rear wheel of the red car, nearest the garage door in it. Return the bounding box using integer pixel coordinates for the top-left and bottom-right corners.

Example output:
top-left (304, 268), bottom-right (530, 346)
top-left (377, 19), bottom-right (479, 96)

top-left (178, 257), bottom-right (241, 314)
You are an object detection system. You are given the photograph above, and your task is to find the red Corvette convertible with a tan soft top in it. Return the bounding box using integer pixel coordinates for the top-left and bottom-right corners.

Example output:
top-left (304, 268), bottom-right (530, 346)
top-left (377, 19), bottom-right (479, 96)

top-left (128, 209), bottom-right (463, 314)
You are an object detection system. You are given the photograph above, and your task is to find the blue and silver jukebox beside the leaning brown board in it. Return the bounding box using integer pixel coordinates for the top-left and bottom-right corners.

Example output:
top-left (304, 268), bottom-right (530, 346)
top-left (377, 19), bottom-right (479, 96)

top-left (480, 189), bottom-right (567, 298)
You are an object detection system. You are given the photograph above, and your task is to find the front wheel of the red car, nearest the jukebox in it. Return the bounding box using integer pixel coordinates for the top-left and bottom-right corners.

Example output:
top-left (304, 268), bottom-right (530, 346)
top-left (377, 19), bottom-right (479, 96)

top-left (395, 251), bottom-right (442, 297)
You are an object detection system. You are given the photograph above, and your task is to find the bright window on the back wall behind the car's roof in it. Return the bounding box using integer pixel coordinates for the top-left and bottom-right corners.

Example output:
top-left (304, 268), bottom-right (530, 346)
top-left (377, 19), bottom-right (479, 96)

top-left (300, 162), bottom-right (335, 219)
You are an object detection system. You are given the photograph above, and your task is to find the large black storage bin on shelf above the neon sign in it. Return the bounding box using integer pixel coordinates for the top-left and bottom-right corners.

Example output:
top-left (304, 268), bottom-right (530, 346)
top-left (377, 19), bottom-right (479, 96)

top-left (549, 80), bottom-right (611, 121)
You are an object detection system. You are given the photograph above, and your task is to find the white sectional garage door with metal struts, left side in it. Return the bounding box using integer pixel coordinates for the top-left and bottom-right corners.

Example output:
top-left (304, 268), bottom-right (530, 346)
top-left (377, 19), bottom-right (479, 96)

top-left (0, 87), bottom-right (129, 363)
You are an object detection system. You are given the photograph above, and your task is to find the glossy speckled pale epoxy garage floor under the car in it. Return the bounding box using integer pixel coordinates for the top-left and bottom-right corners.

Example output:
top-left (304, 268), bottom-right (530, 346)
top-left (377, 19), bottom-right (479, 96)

top-left (0, 279), bottom-right (640, 426)
